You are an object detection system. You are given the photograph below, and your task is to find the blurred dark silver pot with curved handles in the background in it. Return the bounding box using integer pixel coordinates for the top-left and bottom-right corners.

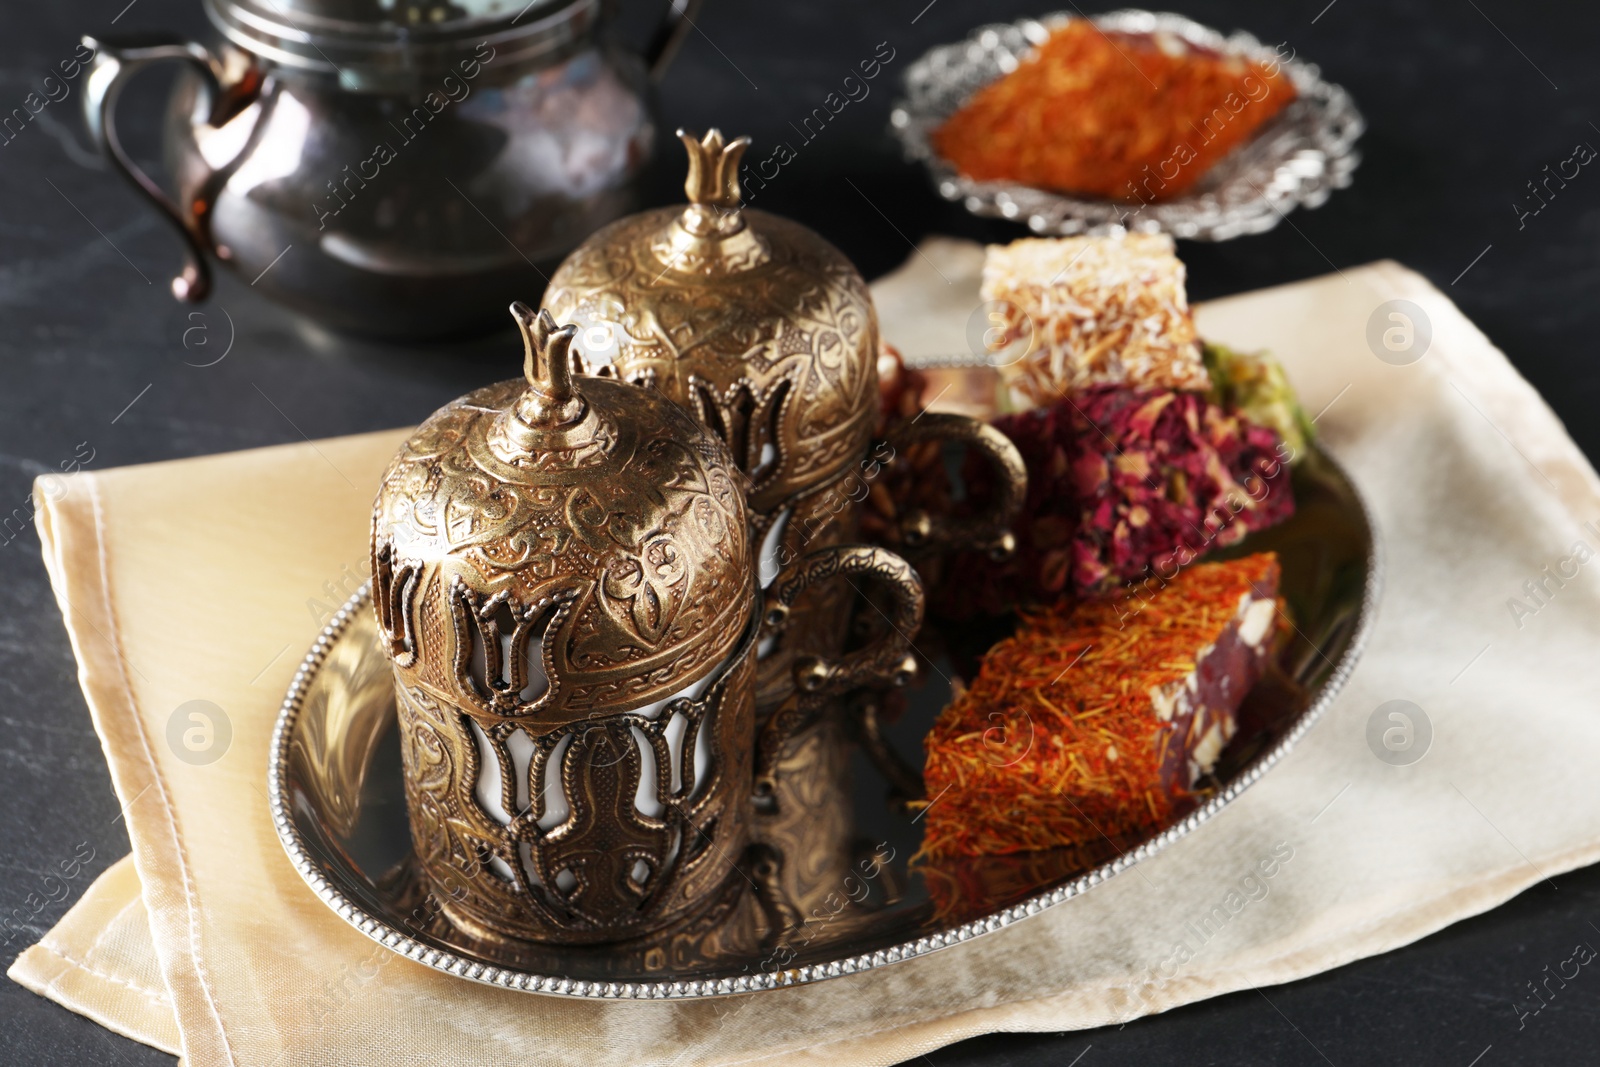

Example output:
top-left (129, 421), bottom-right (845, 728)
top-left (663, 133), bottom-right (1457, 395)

top-left (83, 0), bottom-right (699, 338)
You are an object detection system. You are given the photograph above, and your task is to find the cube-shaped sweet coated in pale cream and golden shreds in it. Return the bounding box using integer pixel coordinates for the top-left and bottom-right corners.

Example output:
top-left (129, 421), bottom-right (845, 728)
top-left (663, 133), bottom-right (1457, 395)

top-left (981, 234), bottom-right (1211, 406)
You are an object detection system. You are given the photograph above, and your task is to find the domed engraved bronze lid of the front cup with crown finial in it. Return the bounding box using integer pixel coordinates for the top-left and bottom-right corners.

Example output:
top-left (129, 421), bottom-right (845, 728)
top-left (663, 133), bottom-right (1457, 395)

top-left (371, 304), bottom-right (754, 729)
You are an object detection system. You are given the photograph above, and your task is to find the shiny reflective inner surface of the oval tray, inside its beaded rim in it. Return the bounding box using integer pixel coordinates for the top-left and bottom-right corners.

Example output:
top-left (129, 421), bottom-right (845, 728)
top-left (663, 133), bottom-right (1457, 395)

top-left (285, 453), bottom-right (1373, 982)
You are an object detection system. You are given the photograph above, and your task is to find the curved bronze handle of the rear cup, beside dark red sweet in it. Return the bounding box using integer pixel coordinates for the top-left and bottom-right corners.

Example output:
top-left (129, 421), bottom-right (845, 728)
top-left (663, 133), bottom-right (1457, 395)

top-left (888, 411), bottom-right (1027, 561)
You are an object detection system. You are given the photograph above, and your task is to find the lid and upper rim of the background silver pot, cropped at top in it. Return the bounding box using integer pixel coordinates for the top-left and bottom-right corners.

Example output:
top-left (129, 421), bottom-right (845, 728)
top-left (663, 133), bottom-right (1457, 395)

top-left (203, 0), bottom-right (602, 91)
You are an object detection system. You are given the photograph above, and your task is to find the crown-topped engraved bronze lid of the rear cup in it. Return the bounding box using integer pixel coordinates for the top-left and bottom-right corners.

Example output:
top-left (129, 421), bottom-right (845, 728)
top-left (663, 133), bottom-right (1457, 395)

top-left (544, 130), bottom-right (878, 512)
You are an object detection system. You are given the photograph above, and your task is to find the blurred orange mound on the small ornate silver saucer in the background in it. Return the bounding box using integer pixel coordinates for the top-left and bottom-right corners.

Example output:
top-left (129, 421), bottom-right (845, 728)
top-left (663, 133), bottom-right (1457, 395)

top-left (933, 19), bottom-right (1296, 203)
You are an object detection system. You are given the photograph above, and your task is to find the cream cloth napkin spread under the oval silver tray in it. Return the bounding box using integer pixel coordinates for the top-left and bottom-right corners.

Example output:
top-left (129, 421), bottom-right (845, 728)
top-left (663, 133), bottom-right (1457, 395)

top-left (10, 255), bottom-right (1600, 1067)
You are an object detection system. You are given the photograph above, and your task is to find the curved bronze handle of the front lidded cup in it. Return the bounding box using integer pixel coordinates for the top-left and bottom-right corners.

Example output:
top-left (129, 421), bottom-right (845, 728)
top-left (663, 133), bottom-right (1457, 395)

top-left (755, 544), bottom-right (923, 805)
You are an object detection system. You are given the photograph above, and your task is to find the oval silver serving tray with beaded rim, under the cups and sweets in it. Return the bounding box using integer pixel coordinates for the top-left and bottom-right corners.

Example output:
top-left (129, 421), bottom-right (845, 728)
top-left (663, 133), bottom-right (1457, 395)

top-left (269, 450), bottom-right (1381, 998)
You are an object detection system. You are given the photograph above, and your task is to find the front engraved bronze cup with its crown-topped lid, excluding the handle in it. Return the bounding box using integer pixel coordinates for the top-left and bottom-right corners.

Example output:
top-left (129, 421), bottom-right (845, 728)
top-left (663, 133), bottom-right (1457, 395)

top-left (373, 334), bottom-right (757, 942)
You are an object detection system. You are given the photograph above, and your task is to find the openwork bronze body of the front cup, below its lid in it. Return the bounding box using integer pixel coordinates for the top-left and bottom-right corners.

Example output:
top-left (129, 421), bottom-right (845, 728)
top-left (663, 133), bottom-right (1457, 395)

top-left (398, 624), bottom-right (755, 942)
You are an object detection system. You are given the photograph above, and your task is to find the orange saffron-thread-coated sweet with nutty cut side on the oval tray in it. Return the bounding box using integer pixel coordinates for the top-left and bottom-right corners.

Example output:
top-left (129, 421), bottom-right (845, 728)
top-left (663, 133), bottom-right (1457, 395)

top-left (922, 553), bottom-right (1278, 861)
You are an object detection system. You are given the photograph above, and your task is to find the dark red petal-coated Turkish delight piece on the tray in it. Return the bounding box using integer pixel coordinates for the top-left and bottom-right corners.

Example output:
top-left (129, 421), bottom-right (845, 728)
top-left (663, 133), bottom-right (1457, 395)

top-left (930, 387), bottom-right (1294, 617)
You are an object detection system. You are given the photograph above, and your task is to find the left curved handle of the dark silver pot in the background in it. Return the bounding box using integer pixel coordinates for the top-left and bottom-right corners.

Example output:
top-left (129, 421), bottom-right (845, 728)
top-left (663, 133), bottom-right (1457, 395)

top-left (83, 37), bottom-right (237, 301)
